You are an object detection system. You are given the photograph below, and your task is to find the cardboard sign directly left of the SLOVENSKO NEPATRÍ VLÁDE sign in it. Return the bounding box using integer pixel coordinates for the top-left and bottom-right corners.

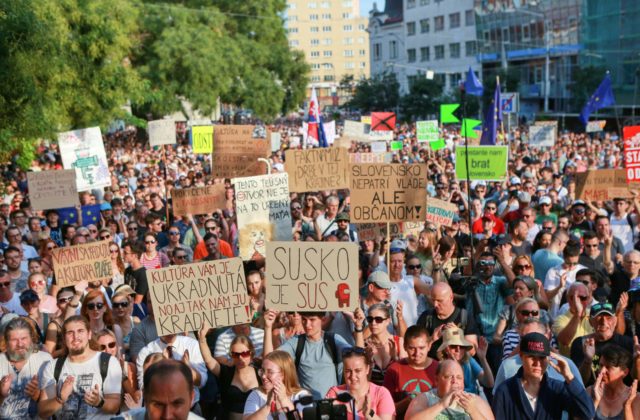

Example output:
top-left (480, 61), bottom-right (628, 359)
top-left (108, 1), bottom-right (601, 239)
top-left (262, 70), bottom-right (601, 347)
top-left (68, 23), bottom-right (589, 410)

top-left (284, 147), bottom-right (349, 192)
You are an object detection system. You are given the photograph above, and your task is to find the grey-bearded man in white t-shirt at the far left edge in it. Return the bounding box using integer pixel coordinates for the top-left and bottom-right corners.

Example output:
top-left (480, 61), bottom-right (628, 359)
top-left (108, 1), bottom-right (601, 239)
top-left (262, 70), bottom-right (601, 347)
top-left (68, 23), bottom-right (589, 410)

top-left (0, 315), bottom-right (51, 419)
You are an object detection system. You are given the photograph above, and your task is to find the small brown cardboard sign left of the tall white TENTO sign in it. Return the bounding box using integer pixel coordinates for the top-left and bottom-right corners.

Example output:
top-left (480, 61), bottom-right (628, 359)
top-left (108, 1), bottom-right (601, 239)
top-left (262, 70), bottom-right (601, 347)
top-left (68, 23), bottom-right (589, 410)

top-left (171, 184), bottom-right (227, 216)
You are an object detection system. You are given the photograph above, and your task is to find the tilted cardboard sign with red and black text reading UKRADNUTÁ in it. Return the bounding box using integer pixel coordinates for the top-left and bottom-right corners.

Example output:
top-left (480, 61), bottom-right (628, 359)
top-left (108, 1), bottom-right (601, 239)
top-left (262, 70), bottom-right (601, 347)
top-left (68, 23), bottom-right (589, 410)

top-left (147, 258), bottom-right (251, 336)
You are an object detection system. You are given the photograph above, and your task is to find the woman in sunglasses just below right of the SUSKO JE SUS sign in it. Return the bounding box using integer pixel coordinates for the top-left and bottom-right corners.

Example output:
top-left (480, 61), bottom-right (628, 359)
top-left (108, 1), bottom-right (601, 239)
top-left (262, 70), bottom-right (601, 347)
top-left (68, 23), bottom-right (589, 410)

top-left (365, 303), bottom-right (407, 385)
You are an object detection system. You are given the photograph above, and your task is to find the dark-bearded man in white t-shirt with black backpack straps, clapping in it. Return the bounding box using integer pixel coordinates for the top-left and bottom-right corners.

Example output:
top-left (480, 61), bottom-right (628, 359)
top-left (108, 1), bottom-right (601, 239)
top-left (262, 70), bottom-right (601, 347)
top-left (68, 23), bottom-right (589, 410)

top-left (38, 316), bottom-right (122, 420)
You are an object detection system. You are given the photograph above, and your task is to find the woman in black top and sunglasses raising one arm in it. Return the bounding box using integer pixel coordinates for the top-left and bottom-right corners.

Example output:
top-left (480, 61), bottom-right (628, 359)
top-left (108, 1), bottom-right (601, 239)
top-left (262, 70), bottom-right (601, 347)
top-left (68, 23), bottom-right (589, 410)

top-left (198, 327), bottom-right (260, 420)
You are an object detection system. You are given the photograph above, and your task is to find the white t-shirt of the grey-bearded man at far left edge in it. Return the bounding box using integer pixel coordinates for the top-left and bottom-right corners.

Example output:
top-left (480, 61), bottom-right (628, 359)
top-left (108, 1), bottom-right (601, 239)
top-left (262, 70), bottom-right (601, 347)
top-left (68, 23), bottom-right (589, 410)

top-left (0, 351), bottom-right (51, 419)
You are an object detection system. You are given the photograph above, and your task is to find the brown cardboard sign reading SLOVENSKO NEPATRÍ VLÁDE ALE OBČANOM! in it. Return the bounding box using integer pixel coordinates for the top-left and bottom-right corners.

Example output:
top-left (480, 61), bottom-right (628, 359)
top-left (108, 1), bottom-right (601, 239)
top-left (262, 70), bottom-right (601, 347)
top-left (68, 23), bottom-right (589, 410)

top-left (351, 163), bottom-right (427, 222)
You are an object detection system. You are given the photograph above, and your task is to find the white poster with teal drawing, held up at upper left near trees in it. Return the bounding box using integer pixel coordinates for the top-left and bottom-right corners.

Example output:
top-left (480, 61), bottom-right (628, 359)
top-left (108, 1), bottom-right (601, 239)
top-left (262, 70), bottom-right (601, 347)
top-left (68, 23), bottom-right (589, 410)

top-left (58, 127), bottom-right (111, 191)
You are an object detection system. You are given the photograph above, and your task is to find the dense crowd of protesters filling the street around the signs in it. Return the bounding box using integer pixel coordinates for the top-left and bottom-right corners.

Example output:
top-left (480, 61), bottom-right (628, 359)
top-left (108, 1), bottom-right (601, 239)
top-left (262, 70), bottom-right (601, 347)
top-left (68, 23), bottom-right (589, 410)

top-left (0, 119), bottom-right (640, 420)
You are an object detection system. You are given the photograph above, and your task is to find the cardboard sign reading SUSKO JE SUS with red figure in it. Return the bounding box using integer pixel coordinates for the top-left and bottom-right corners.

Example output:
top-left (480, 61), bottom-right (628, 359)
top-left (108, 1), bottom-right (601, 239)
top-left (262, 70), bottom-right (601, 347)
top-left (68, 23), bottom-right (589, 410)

top-left (265, 242), bottom-right (359, 312)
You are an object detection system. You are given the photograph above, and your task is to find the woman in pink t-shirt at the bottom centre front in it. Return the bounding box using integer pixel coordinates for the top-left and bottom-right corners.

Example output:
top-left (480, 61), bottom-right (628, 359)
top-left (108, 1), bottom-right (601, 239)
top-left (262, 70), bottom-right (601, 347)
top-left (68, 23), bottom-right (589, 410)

top-left (326, 347), bottom-right (396, 420)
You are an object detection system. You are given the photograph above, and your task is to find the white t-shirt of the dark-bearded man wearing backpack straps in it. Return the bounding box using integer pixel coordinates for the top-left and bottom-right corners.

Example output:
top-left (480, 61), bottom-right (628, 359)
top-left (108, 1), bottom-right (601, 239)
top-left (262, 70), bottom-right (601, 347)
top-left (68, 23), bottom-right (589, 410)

top-left (41, 352), bottom-right (122, 420)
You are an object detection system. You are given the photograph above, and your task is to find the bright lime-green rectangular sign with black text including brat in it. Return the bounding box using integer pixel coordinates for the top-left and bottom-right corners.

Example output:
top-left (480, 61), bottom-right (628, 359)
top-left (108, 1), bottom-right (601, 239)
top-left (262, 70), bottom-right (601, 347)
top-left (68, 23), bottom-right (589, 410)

top-left (456, 146), bottom-right (509, 181)
